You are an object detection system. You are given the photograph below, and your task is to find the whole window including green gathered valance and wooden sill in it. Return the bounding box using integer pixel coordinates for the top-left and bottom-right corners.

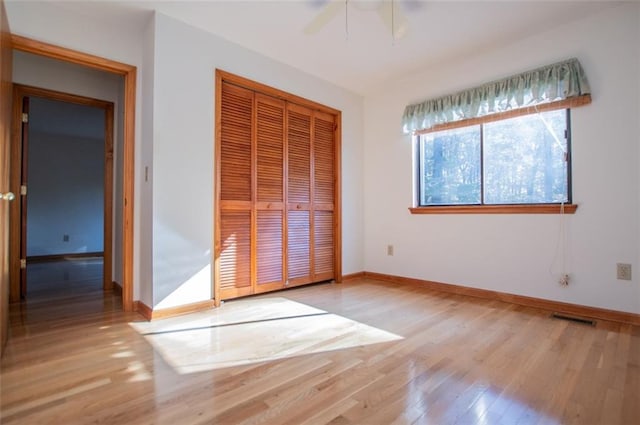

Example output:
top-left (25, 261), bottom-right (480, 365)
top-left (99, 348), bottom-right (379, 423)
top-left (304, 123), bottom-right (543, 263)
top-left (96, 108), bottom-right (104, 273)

top-left (402, 58), bottom-right (591, 214)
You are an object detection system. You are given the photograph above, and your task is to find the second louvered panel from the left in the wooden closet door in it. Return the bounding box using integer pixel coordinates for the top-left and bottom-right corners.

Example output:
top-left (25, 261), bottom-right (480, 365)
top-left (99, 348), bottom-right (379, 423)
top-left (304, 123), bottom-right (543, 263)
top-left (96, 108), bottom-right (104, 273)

top-left (255, 94), bottom-right (285, 292)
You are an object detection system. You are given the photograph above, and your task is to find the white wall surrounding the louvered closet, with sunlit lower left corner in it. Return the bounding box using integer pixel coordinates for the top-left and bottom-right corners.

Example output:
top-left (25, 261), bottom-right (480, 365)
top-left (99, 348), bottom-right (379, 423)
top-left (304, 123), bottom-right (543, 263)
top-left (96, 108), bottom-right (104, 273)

top-left (153, 14), bottom-right (363, 308)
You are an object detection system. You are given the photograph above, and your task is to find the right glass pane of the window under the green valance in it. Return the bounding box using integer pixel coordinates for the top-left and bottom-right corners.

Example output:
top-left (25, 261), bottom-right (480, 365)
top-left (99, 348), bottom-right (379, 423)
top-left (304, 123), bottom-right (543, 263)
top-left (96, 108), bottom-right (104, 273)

top-left (483, 109), bottom-right (569, 204)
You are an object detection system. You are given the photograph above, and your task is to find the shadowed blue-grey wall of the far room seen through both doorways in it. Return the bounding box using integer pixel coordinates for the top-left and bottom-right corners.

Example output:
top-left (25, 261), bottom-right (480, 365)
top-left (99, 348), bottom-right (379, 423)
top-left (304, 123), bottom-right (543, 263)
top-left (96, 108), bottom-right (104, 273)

top-left (27, 129), bottom-right (104, 256)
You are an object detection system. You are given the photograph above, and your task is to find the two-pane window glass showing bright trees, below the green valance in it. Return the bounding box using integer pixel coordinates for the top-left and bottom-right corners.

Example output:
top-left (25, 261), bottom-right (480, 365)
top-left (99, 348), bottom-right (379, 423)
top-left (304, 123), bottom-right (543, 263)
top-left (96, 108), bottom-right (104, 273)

top-left (416, 109), bottom-right (571, 207)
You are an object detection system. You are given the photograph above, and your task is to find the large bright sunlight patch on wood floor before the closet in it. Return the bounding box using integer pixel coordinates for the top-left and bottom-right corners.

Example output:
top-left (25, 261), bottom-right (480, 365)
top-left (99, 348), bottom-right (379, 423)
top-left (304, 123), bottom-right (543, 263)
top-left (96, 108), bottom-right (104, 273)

top-left (130, 297), bottom-right (402, 374)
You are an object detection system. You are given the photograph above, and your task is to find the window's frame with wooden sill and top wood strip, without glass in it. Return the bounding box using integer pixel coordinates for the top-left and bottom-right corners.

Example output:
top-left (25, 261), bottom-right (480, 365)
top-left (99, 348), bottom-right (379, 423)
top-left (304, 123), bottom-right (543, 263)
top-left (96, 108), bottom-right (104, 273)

top-left (409, 94), bottom-right (591, 214)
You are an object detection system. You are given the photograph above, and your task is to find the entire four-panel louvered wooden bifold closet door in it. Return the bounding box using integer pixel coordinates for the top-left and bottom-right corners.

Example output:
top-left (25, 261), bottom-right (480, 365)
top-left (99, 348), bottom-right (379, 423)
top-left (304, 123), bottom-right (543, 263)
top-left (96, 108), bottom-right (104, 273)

top-left (214, 71), bottom-right (341, 304)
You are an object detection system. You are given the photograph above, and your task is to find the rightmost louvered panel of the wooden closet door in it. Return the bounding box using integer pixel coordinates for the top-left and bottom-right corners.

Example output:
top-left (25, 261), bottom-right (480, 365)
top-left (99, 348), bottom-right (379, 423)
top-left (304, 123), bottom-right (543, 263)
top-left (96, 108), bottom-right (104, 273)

top-left (313, 112), bottom-right (335, 282)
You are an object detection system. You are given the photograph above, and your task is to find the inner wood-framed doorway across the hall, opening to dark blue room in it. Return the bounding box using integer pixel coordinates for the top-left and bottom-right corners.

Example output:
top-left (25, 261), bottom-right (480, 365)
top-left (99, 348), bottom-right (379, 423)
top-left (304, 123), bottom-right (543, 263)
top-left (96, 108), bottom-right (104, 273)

top-left (14, 89), bottom-right (114, 298)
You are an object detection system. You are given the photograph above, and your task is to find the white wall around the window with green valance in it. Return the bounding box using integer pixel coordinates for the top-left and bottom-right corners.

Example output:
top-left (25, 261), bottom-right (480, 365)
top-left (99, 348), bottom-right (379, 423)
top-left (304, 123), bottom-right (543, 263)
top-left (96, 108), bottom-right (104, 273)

top-left (364, 3), bottom-right (640, 313)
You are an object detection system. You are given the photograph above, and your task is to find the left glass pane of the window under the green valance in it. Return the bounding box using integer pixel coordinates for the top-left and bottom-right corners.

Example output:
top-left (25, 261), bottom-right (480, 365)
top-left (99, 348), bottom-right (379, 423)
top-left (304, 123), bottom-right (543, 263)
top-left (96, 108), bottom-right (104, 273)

top-left (420, 125), bottom-right (481, 205)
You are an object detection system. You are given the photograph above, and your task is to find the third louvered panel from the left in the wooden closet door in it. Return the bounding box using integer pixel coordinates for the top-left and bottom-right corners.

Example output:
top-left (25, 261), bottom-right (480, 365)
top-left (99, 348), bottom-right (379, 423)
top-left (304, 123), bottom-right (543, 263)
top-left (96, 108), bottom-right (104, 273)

top-left (287, 104), bottom-right (313, 285)
